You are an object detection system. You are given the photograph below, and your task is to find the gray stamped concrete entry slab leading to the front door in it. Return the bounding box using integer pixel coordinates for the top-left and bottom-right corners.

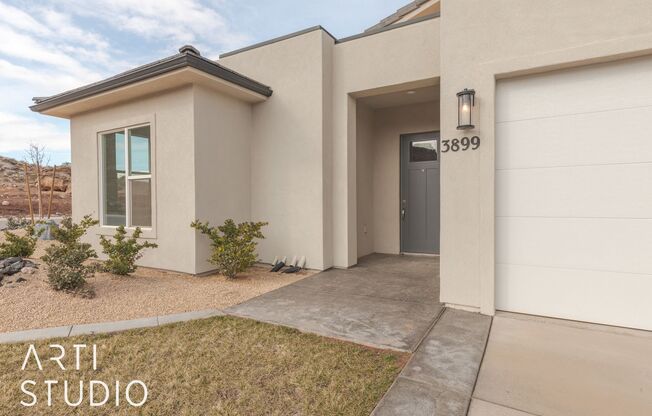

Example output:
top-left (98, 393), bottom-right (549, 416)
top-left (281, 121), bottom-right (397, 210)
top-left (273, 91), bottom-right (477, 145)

top-left (225, 254), bottom-right (442, 351)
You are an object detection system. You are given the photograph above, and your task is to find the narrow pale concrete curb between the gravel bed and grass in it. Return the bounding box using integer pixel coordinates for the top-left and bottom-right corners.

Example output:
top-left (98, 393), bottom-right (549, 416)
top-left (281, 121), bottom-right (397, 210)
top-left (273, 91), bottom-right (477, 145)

top-left (0, 309), bottom-right (224, 344)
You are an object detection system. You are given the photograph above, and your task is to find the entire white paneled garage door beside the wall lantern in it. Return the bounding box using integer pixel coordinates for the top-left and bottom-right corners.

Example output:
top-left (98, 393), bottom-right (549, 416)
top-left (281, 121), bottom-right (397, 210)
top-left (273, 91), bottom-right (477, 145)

top-left (496, 58), bottom-right (652, 330)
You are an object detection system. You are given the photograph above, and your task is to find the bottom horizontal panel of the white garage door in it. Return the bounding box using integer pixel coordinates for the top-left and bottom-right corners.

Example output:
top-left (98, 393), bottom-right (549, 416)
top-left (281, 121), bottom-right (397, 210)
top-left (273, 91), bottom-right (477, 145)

top-left (496, 265), bottom-right (652, 330)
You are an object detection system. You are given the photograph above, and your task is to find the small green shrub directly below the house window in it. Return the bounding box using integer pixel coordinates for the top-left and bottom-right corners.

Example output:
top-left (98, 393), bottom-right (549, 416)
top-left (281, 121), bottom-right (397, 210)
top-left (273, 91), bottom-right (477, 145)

top-left (100, 226), bottom-right (158, 276)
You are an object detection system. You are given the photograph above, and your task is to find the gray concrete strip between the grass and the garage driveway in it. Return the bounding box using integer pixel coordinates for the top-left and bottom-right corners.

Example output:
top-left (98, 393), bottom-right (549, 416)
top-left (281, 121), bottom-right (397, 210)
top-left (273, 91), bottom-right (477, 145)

top-left (373, 309), bottom-right (491, 416)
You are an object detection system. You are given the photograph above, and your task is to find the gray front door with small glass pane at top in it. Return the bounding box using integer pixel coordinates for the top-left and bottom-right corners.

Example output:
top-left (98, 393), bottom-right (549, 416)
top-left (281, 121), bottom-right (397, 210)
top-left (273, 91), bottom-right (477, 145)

top-left (399, 132), bottom-right (440, 254)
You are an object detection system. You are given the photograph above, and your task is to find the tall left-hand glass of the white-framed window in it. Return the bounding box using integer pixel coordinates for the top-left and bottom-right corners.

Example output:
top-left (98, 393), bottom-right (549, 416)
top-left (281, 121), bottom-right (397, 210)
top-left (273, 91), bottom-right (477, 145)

top-left (102, 132), bottom-right (126, 225)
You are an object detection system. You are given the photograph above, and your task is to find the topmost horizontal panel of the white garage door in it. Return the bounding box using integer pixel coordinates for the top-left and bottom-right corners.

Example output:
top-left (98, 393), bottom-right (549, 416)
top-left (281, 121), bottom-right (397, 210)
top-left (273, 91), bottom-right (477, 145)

top-left (496, 58), bottom-right (652, 122)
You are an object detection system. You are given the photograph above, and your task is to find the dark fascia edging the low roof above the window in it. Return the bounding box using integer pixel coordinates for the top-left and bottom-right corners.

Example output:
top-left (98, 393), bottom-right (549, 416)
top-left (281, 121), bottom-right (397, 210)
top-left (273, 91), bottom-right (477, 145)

top-left (30, 53), bottom-right (272, 112)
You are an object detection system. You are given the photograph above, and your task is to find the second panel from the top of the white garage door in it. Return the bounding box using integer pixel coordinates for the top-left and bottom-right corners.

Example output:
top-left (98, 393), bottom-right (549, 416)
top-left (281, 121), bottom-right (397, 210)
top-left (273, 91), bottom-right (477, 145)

top-left (496, 107), bottom-right (652, 170)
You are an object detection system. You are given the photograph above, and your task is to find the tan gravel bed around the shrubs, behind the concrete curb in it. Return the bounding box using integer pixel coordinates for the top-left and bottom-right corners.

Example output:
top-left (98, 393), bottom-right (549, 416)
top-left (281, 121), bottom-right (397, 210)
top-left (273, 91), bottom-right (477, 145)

top-left (0, 236), bottom-right (315, 332)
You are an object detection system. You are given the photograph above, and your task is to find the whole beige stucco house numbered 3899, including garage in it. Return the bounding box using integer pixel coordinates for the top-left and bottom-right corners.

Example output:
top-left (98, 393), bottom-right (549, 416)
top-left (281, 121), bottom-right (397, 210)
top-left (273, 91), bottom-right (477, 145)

top-left (31, 0), bottom-right (652, 330)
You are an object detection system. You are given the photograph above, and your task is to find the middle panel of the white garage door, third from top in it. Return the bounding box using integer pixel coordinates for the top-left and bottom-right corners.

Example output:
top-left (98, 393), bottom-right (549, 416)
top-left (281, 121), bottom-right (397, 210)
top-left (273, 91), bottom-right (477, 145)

top-left (496, 163), bottom-right (652, 218)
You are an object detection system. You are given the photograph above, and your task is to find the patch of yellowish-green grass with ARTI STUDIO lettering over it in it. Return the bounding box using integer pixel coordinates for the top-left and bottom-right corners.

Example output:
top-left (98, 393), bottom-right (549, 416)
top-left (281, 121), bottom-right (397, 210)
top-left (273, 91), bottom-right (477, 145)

top-left (0, 317), bottom-right (408, 416)
